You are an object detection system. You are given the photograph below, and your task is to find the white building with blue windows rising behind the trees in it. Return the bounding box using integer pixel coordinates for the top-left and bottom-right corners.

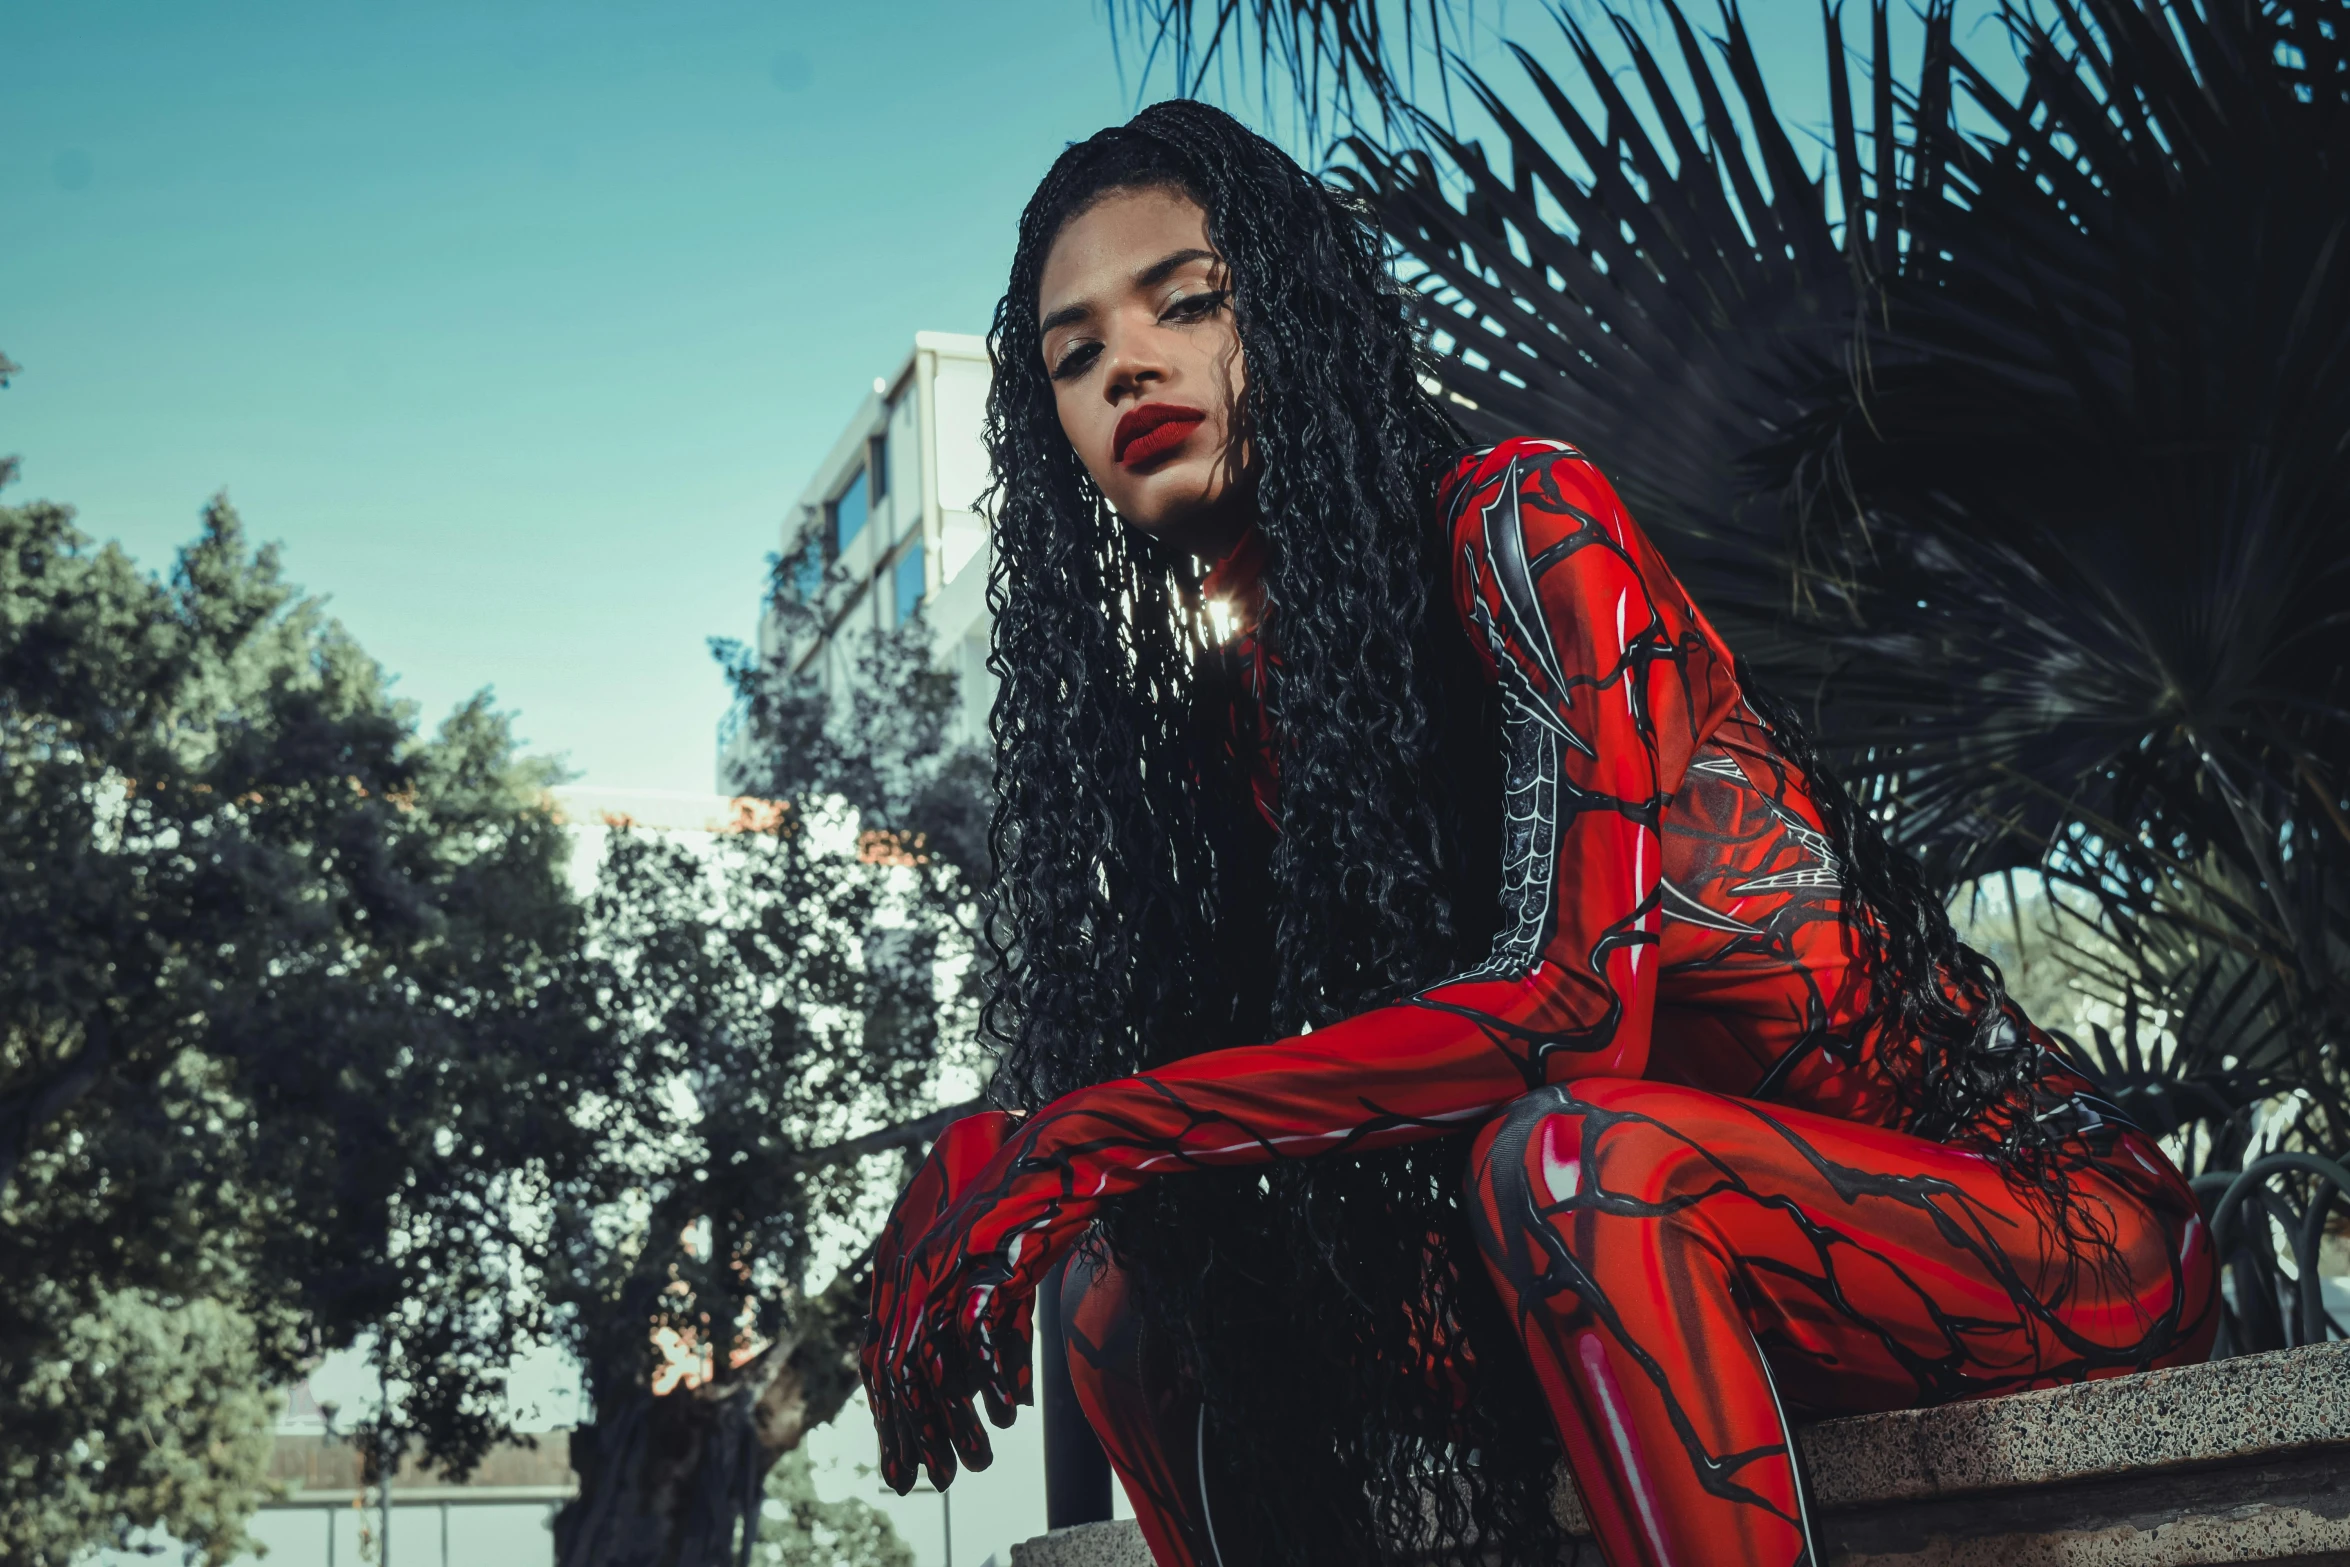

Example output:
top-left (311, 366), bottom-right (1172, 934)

top-left (717, 331), bottom-right (994, 794)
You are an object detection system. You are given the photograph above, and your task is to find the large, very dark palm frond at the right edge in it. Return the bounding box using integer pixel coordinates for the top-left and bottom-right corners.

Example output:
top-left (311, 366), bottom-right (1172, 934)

top-left (1784, 0), bottom-right (2350, 1139)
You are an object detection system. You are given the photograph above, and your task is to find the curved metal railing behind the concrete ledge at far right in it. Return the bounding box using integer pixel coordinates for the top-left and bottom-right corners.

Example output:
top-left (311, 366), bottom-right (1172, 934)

top-left (2193, 1154), bottom-right (2350, 1360)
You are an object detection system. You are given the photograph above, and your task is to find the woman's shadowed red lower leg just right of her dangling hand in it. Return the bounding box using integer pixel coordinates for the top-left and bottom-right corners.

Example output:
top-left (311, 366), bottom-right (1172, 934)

top-left (1060, 1255), bottom-right (1220, 1567)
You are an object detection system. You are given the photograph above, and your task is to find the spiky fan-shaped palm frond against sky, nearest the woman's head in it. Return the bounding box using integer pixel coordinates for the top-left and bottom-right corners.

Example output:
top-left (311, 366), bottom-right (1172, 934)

top-left (1340, 2), bottom-right (1948, 667)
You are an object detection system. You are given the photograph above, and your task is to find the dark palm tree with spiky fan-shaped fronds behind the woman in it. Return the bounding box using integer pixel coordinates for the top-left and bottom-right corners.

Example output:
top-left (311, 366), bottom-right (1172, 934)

top-left (1126, 0), bottom-right (2350, 1165)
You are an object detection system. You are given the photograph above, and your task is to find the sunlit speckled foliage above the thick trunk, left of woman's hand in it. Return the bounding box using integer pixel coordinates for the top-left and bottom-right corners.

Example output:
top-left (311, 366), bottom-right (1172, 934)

top-left (550, 811), bottom-right (940, 1391)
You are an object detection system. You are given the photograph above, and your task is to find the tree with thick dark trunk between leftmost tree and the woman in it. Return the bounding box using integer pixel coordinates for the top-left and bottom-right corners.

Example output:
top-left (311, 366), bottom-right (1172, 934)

top-left (550, 535), bottom-right (985, 1567)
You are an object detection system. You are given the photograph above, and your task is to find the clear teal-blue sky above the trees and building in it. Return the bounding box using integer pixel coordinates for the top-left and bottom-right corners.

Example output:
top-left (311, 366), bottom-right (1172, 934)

top-left (0, 0), bottom-right (1983, 789)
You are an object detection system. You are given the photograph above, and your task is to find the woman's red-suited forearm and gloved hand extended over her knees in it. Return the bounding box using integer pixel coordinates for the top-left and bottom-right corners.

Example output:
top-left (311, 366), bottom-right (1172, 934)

top-left (860, 1005), bottom-right (1541, 1494)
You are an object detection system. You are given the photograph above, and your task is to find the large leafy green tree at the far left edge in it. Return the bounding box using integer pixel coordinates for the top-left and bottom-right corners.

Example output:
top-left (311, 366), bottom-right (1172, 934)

top-left (0, 483), bottom-right (595, 1562)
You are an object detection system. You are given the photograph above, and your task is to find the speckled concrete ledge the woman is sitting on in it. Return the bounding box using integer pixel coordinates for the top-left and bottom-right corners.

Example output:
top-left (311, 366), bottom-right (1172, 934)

top-left (1013, 1344), bottom-right (2350, 1567)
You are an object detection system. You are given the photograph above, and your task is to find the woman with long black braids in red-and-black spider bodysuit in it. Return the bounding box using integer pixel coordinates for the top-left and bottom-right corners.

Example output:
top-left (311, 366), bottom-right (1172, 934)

top-left (862, 103), bottom-right (2214, 1567)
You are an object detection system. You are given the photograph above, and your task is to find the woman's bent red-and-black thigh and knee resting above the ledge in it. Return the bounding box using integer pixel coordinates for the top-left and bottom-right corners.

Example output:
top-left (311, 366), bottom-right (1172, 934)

top-left (1471, 1078), bottom-right (2214, 1412)
